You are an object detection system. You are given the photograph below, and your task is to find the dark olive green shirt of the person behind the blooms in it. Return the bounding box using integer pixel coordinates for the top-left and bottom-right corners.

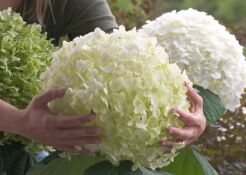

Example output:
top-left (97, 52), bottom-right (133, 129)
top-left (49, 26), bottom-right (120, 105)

top-left (18, 0), bottom-right (118, 45)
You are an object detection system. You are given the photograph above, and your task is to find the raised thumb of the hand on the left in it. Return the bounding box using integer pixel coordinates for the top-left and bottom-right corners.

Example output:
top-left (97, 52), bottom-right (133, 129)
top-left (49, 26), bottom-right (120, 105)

top-left (33, 88), bottom-right (66, 106)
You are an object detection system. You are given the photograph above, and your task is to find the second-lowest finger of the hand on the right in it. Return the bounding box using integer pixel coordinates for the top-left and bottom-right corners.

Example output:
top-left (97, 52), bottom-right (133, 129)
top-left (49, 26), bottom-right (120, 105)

top-left (167, 127), bottom-right (199, 140)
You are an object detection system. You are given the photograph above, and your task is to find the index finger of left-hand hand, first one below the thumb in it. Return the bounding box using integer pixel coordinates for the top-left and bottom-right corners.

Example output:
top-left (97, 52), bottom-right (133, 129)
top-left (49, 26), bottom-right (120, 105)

top-left (57, 115), bottom-right (95, 128)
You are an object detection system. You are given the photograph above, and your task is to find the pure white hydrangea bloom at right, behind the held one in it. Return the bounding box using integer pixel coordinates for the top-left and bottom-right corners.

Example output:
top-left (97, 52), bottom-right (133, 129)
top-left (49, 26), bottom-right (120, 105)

top-left (140, 9), bottom-right (246, 111)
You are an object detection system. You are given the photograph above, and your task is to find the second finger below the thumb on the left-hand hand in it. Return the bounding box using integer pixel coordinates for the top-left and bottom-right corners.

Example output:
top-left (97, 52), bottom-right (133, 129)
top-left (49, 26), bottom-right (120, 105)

top-left (59, 126), bottom-right (102, 140)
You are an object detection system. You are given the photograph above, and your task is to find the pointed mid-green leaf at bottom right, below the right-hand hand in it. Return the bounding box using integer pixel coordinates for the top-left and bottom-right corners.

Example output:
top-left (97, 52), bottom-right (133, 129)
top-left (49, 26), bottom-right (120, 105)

top-left (162, 146), bottom-right (218, 175)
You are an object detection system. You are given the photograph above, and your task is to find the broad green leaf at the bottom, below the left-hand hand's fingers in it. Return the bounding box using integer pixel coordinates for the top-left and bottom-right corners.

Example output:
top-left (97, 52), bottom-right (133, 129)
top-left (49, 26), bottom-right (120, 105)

top-left (27, 155), bottom-right (103, 175)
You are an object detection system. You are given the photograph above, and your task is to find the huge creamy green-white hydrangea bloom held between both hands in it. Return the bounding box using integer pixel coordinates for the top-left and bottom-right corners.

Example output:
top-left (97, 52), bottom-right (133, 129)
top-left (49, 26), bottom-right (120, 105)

top-left (42, 27), bottom-right (188, 169)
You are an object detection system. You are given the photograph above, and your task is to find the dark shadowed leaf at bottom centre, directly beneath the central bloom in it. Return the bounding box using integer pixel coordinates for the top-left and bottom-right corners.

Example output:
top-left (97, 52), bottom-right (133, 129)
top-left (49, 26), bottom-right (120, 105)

top-left (84, 161), bottom-right (171, 175)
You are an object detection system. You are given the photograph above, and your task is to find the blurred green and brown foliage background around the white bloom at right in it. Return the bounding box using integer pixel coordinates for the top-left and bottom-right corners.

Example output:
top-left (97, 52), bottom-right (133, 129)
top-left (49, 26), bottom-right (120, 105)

top-left (108, 0), bottom-right (246, 175)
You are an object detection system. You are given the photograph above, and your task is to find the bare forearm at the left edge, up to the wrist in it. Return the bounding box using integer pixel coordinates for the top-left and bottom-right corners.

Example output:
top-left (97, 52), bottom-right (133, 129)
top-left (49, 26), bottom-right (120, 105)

top-left (0, 99), bottom-right (22, 133)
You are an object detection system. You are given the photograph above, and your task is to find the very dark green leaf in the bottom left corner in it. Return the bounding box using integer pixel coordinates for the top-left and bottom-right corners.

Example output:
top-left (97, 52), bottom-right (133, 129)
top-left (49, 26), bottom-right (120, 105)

top-left (0, 142), bottom-right (36, 175)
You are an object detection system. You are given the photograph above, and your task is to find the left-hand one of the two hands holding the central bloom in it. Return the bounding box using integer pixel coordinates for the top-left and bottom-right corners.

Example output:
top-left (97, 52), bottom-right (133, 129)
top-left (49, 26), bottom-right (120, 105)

top-left (16, 89), bottom-right (101, 153)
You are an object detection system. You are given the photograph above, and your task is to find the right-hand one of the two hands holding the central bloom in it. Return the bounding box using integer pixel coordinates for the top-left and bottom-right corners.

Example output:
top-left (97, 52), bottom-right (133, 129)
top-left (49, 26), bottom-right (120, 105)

top-left (161, 82), bottom-right (206, 146)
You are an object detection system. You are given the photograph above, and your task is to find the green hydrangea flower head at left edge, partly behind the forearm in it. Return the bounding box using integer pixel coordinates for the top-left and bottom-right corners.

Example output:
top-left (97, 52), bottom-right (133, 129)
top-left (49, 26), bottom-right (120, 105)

top-left (0, 9), bottom-right (55, 151)
